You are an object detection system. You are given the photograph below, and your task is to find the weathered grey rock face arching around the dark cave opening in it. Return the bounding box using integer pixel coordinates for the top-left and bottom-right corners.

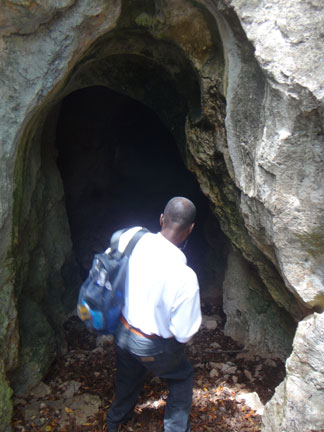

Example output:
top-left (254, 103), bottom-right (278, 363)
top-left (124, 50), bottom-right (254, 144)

top-left (0, 0), bottom-right (324, 431)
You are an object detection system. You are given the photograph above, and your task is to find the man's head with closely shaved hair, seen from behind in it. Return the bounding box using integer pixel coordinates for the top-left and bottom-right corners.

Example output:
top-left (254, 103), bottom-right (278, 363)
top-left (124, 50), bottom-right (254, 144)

top-left (160, 197), bottom-right (196, 245)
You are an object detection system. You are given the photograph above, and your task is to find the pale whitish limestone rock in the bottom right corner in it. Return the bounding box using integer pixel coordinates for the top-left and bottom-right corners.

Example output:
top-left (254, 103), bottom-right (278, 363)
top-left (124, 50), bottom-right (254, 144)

top-left (262, 313), bottom-right (324, 432)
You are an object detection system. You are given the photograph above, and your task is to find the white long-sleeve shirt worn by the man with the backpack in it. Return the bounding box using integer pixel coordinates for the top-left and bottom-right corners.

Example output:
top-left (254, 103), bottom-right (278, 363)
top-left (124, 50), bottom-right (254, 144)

top-left (119, 227), bottom-right (201, 343)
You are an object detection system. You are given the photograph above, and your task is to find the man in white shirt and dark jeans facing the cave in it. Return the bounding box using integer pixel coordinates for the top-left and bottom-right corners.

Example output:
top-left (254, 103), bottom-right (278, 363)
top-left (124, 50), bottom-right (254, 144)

top-left (107, 197), bottom-right (201, 432)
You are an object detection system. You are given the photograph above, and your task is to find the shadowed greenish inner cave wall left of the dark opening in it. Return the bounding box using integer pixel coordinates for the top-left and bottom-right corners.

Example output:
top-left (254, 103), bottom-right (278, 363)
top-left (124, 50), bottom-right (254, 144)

top-left (9, 105), bottom-right (80, 395)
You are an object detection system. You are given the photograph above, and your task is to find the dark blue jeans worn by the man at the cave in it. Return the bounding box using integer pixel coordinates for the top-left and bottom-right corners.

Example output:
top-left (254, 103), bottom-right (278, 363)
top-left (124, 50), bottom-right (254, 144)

top-left (107, 323), bottom-right (193, 432)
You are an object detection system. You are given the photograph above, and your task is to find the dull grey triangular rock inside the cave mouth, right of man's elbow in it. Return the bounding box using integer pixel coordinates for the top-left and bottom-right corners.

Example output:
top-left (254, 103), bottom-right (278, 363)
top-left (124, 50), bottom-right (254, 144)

top-left (223, 246), bottom-right (295, 361)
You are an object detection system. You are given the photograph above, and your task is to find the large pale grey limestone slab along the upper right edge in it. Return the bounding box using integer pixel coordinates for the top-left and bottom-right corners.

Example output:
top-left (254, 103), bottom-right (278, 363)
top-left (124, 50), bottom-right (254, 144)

top-left (221, 0), bottom-right (324, 307)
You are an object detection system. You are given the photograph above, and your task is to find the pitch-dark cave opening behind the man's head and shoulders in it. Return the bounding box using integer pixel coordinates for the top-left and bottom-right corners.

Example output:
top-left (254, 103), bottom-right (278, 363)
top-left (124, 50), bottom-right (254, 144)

top-left (56, 86), bottom-right (227, 301)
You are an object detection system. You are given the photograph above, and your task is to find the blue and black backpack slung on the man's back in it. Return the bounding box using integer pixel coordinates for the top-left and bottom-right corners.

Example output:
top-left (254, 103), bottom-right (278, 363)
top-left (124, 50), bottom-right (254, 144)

top-left (77, 228), bottom-right (149, 334)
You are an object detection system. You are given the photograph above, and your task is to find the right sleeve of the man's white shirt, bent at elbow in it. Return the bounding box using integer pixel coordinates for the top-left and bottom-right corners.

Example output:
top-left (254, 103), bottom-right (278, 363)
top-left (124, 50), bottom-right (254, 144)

top-left (170, 268), bottom-right (201, 343)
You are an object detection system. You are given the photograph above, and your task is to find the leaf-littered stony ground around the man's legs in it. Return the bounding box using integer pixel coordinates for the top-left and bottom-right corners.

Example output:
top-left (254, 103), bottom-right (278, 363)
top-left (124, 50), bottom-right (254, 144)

top-left (13, 305), bottom-right (285, 432)
